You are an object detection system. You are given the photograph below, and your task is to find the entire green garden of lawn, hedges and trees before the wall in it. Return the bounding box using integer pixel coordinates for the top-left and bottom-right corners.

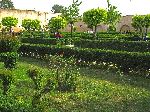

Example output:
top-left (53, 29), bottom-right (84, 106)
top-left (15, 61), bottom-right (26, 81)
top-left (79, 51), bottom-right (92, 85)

top-left (0, 1), bottom-right (150, 112)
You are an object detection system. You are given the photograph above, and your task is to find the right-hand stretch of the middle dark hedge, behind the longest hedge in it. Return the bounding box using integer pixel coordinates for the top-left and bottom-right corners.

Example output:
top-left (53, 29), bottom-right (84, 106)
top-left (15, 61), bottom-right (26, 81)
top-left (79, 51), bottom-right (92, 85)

top-left (75, 39), bottom-right (150, 52)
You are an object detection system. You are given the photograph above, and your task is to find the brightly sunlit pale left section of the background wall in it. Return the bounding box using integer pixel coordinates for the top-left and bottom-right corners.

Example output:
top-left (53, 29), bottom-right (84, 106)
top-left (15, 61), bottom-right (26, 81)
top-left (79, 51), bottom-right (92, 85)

top-left (0, 9), bottom-right (60, 26)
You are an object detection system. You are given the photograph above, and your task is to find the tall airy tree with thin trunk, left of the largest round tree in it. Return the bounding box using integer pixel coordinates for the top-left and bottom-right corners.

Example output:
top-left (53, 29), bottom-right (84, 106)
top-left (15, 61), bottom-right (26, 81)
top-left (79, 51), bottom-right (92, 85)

top-left (61, 0), bottom-right (82, 37)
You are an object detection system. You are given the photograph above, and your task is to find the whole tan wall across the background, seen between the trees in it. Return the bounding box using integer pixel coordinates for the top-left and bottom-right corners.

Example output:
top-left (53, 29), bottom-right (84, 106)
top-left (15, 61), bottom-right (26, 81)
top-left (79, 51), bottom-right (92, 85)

top-left (0, 9), bottom-right (150, 32)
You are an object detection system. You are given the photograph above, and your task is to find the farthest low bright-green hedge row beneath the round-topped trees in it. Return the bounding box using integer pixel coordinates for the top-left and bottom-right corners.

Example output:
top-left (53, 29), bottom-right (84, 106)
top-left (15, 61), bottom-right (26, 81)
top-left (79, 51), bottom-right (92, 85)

top-left (21, 31), bottom-right (134, 40)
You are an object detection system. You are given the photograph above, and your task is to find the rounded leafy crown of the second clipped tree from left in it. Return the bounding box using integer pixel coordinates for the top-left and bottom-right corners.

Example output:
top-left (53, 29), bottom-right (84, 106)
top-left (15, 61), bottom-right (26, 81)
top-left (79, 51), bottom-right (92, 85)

top-left (22, 19), bottom-right (41, 32)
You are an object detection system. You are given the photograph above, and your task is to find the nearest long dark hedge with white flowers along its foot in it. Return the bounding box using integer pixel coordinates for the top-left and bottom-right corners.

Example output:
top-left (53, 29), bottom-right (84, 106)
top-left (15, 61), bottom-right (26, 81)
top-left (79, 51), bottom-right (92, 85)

top-left (19, 45), bottom-right (150, 72)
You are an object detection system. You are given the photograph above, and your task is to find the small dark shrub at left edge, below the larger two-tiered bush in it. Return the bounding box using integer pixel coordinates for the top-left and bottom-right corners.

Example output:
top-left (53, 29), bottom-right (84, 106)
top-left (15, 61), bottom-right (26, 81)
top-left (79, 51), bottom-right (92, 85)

top-left (0, 69), bottom-right (13, 95)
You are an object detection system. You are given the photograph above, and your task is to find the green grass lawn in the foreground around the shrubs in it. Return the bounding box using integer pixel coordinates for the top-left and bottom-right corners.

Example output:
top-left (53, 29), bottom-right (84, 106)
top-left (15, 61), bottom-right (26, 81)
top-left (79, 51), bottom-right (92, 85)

top-left (0, 58), bottom-right (150, 112)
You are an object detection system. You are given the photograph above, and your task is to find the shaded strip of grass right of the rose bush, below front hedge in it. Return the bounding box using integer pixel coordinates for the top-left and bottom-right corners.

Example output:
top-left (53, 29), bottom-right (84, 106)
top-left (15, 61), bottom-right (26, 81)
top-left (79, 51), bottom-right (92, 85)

top-left (80, 68), bottom-right (150, 91)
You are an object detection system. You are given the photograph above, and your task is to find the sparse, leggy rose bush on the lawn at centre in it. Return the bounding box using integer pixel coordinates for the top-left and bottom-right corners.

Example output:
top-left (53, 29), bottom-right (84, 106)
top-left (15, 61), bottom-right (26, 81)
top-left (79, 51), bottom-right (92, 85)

top-left (48, 54), bottom-right (79, 92)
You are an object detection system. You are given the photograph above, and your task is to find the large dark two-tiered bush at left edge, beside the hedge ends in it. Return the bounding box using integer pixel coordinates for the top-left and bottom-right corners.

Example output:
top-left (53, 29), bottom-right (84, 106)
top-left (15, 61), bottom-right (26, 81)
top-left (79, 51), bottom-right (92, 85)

top-left (0, 37), bottom-right (20, 69)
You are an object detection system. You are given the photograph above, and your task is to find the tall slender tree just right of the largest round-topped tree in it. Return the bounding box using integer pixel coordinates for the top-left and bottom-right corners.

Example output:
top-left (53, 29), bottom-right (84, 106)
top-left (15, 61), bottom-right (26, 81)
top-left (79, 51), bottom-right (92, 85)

top-left (106, 0), bottom-right (121, 31)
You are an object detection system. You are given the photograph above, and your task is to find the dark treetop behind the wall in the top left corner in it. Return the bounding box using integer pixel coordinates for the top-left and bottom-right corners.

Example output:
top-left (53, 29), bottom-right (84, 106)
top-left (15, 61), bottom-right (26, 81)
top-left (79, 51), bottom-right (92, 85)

top-left (0, 0), bottom-right (15, 9)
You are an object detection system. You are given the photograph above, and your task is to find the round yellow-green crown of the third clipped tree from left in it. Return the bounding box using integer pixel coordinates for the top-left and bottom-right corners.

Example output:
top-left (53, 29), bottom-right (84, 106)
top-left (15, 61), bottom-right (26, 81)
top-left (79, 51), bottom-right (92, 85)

top-left (48, 16), bottom-right (67, 32)
